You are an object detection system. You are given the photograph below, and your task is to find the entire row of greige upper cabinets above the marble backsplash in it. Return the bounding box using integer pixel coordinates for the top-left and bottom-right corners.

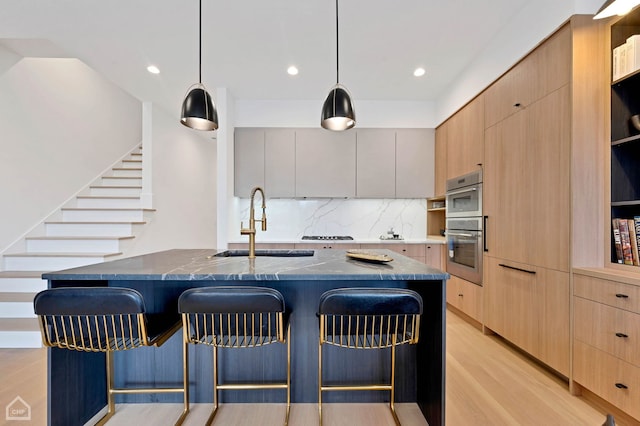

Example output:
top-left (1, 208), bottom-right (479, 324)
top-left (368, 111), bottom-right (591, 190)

top-left (234, 128), bottom-right (435, 198)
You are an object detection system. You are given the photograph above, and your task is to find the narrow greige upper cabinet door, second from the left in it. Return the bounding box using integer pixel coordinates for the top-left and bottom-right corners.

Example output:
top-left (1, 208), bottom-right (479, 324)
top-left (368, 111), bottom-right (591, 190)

top-left (264, 128), bottom-right (296, 198)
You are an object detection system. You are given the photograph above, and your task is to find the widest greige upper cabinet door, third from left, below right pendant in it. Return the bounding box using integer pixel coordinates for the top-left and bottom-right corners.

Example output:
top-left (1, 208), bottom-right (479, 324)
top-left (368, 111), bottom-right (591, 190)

top-left (296, 129), bottom-right (356, 198)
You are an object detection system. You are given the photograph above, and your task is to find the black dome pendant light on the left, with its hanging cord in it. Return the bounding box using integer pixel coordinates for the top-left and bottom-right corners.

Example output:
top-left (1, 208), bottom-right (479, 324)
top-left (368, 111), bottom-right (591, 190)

top-left (180, 0), bottom-right (218, 130)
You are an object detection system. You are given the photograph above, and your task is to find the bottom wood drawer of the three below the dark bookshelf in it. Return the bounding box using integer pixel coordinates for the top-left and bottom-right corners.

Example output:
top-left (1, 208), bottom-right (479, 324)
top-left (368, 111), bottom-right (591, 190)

top-left (573, 341), bottom-right (640, 420)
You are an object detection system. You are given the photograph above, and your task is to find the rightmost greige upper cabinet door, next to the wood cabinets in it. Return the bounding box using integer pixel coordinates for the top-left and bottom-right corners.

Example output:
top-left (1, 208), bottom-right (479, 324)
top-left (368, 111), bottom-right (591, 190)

top-left (396, 129), bottom-right (435, 198)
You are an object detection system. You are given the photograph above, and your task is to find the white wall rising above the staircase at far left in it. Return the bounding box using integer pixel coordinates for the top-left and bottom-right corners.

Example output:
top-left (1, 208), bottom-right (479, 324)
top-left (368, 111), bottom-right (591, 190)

top-left (0, 58), bottom-right (141, 252)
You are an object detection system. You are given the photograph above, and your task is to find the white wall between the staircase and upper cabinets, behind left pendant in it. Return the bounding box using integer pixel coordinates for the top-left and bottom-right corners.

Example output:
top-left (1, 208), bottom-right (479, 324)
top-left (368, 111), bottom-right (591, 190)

top-left (127, 105), bottom-right (217, 255)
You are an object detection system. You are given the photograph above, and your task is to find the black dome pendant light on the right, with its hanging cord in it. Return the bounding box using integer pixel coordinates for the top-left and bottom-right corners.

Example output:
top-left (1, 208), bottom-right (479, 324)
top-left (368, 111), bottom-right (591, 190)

top-left (320, 0), bottom-right (356, 131)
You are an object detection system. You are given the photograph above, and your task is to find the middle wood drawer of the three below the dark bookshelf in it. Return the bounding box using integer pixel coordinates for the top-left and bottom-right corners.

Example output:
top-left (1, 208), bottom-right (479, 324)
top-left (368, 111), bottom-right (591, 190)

top-left (574, 297), bottom-right (640, 367)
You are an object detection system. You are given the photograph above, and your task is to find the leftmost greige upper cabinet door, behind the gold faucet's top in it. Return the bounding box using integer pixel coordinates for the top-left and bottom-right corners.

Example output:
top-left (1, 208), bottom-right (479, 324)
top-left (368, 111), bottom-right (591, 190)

top-left (234, 128), bottom-right (265, 198)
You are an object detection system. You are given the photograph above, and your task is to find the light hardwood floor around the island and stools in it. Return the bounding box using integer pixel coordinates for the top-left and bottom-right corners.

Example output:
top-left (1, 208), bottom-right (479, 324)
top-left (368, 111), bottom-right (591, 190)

top-left (0, 313), bottom-right (621, 426)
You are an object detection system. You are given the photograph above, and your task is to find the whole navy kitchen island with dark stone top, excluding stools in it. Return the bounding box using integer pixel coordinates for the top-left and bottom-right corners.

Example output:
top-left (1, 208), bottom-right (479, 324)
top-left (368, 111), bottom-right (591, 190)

top-left (43, 249), bottom-right (448, 426)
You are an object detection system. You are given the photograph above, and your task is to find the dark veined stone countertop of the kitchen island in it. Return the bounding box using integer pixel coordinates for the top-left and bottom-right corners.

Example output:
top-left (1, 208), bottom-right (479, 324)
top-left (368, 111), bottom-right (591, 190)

top-left (42, 249), bottom-right (449, 281)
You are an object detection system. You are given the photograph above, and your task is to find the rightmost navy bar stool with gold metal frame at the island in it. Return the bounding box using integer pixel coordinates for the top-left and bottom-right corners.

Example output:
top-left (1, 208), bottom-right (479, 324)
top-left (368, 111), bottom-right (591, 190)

top-left (318, 288), bottom-right (422, 425)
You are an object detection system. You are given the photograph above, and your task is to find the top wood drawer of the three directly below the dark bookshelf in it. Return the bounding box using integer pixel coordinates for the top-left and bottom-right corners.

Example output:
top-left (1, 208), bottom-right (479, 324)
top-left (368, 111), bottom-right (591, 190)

top-left (573, 274), bottom-right (640, 313)
